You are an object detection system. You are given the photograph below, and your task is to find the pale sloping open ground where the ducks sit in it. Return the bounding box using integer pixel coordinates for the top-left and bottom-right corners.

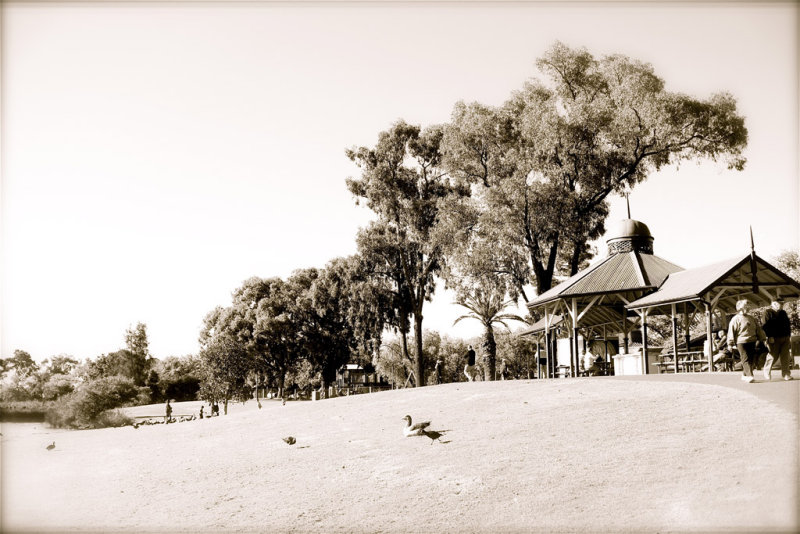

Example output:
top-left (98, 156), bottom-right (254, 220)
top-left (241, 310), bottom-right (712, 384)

top-left (2, 373), bottom-right (800, 532)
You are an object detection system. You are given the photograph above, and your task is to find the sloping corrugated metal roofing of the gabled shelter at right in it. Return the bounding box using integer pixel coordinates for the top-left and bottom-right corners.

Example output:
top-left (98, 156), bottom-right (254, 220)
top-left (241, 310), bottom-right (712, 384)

top-left (627, 254), bottom-right (800, 309)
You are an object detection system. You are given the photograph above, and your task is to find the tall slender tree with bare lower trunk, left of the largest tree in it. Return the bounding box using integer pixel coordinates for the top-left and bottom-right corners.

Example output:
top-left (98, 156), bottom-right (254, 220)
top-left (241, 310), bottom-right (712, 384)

top-left (347, 121), bottom-right (468, 386)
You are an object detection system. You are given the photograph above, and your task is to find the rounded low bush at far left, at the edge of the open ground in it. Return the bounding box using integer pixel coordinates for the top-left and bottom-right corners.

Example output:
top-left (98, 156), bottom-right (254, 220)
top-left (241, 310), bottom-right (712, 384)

top-left (45, 376), bottom-right (139, 428)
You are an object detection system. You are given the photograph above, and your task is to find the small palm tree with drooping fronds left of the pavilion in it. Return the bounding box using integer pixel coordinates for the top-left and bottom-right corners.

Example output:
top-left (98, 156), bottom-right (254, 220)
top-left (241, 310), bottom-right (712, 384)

top-left (453, 288), bottom-right (525, 380)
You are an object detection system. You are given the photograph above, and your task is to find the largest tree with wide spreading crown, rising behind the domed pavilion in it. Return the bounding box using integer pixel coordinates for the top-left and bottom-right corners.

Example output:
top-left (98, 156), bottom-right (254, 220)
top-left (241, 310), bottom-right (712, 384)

top-left (443, 43), bottom-right (747, 297)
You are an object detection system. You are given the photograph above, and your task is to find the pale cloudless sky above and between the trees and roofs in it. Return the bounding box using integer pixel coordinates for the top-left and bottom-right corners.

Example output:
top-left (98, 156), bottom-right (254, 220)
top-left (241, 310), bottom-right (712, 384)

top-left (0, 1), bottom-right (800, 360)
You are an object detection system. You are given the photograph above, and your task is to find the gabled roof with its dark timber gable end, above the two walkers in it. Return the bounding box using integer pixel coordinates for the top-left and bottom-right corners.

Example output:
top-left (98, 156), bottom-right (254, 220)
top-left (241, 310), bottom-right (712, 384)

top-left (627, 253), bottom-right (800, 309)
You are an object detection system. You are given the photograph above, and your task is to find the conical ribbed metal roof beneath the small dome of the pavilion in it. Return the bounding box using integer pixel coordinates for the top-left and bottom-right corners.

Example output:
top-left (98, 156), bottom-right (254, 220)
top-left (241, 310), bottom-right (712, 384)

top-left (528, 252), bottom-right (683, 308)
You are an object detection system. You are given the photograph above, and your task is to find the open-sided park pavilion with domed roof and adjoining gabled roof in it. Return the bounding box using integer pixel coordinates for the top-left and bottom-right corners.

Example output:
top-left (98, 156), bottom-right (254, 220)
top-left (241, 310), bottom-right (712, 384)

top-left (521, 219), bottom-right (800, 376)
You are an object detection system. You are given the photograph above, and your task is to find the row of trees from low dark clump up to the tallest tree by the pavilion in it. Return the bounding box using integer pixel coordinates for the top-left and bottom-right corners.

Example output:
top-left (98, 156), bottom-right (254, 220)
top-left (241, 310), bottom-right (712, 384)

top-left (1, 42), bottom-right (747, 426)
